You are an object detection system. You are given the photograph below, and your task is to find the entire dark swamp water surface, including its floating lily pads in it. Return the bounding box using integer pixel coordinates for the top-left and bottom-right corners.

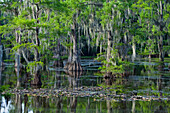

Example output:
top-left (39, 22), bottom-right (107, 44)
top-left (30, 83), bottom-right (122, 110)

top-left (0, 60), bottom-right (170, 113)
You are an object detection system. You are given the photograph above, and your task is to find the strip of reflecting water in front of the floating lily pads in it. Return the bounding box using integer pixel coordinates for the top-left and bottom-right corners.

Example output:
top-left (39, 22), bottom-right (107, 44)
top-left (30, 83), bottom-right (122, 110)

top-left (1, 95), bottom-right (170, 113)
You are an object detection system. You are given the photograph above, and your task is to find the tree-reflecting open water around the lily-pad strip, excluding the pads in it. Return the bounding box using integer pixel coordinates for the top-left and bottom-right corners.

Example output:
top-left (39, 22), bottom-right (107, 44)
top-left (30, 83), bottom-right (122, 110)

top-left (0, 62), bottom-right (170, 113)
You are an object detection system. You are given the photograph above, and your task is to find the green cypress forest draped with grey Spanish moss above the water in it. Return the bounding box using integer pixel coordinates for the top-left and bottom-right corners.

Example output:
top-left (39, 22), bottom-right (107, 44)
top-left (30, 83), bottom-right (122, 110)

top-left (0, 0), bottom-right (170, 77)
